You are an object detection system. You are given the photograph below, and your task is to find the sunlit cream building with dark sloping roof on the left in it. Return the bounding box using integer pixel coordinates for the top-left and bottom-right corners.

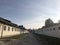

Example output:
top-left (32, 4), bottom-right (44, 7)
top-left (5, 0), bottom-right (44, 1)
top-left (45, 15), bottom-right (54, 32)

top-left (0, 17), bottom-right (21, 37)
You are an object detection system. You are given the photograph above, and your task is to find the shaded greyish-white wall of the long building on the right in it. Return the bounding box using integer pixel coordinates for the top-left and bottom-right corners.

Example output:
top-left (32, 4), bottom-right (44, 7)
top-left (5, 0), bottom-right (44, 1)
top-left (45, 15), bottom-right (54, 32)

top-left (37, 24), bottom-right (60, 38)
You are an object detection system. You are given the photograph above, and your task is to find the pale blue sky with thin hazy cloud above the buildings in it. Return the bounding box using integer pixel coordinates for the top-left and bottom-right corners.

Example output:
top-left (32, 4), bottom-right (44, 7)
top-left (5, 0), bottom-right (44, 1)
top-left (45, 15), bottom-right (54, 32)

top-left (0, 0), bottom-right (60, 28)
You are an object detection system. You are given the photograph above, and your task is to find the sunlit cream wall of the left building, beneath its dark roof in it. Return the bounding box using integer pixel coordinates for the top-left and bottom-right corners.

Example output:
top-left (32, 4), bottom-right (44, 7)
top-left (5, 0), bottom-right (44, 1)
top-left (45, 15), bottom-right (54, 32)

top-left (0, 23), bottom-right (20, 37)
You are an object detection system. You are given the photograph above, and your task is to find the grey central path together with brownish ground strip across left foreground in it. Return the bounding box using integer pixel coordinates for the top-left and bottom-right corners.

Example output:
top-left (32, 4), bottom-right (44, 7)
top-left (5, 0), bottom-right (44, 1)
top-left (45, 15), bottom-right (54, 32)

top-left (0, 33), bottom-right (45, 45)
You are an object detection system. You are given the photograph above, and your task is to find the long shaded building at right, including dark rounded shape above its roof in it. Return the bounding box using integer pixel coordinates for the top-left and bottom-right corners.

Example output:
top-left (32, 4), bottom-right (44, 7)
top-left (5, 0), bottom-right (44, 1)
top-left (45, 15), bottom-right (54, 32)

top-left (35, 19), bottom-right (60, 38)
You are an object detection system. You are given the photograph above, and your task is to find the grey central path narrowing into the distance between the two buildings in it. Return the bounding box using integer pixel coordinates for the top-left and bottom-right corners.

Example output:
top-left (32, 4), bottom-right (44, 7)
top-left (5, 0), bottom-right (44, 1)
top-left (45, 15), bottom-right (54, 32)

top-left (18, 34), bottom-right (42, 45)
